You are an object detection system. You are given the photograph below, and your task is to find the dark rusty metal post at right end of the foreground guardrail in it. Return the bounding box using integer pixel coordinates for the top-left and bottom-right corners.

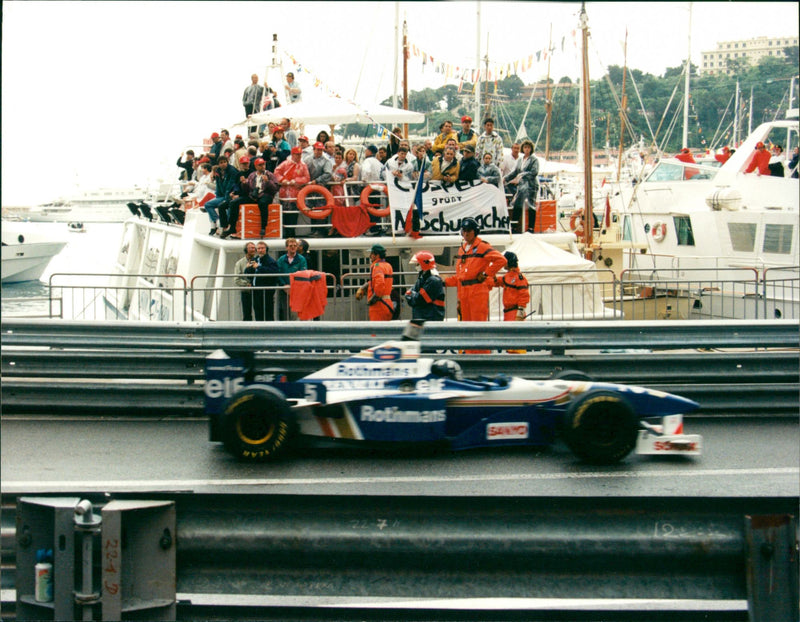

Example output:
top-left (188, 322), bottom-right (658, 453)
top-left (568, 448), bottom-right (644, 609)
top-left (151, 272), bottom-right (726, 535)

top-left (745, 515), bottom-right (798, 622)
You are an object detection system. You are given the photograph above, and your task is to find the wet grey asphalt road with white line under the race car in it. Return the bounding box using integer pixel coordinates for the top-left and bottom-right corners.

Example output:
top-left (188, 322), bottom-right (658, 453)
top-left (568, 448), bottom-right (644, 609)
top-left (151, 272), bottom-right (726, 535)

top-left (0, 416), bottom-right (800, 498)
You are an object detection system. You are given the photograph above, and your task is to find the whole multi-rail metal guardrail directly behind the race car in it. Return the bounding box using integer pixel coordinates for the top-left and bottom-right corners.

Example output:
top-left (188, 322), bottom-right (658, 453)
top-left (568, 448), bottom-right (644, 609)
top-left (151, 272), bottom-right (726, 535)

top-left (1, 320), bottom-right (800, 416)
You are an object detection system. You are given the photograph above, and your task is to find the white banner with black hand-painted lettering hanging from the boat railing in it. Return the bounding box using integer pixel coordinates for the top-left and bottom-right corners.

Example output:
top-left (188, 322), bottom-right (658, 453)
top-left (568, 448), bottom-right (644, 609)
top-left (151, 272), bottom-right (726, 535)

top-left (386, 180), bottom-right (510, 235)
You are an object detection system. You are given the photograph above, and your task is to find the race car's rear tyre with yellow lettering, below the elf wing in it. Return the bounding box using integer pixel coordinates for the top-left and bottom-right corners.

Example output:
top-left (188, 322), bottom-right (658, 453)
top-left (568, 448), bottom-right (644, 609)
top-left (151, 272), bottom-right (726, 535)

top-left (222, 386), bottom-right (296, 462)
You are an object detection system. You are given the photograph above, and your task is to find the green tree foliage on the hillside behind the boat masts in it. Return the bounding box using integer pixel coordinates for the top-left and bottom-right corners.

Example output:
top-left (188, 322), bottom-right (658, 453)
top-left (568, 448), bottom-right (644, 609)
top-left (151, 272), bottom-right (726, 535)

top-left (354, 54), bottom-right (798, 152)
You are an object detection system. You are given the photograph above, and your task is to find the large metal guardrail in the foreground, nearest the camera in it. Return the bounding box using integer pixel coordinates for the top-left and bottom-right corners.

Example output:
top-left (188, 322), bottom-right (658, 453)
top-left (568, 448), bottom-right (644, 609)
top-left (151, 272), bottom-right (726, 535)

top-left (2, 493), bottom-right (797, 622)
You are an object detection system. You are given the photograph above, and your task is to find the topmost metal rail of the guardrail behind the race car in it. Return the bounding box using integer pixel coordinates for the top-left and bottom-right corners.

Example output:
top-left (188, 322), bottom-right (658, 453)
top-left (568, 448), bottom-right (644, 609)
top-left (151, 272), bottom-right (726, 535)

top-left (0, 319), bottom-right (800, 352)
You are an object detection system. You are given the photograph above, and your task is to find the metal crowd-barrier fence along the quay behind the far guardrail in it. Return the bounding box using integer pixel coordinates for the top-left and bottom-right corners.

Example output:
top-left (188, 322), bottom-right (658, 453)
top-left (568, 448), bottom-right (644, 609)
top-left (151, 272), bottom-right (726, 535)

top-left (4, 267), bottom-right (800, 321)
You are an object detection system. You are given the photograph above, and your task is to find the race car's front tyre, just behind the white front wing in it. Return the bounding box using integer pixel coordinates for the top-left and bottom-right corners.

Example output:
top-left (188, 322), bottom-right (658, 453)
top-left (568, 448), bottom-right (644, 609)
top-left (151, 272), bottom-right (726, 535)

top-left (561, 391), bottom-right (639, 464)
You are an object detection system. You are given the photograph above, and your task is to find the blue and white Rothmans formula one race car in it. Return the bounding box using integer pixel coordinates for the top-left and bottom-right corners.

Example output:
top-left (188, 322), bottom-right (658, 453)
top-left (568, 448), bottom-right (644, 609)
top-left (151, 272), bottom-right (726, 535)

top-left (205, 323), bottom-right (702, 464)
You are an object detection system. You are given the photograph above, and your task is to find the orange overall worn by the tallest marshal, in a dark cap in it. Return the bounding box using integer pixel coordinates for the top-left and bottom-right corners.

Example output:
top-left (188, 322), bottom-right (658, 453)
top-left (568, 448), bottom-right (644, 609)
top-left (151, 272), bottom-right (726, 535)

top-left (445, 237), bottom-right (507, 322)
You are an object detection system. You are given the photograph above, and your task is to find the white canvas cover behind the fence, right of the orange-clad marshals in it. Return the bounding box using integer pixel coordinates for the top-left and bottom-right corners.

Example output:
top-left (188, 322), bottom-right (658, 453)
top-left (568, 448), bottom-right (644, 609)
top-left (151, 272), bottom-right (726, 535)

top-left (489, 233), bottom-right (613, 321)
